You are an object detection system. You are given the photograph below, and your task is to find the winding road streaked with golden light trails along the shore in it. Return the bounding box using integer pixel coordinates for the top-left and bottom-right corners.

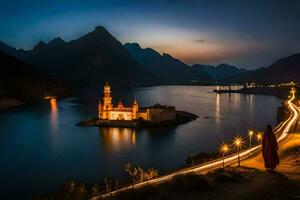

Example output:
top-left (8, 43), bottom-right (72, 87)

top-left (91, 90), bottom-right (300, 200)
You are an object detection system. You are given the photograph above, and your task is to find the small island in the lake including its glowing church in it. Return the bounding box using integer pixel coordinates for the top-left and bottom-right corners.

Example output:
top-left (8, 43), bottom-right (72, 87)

top-left (77, 83), bottom-right (198, 127)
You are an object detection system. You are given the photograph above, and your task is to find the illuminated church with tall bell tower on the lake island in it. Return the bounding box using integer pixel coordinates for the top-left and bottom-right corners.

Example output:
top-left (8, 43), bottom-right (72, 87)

top-left (98, 83), bottom-right (176, 123)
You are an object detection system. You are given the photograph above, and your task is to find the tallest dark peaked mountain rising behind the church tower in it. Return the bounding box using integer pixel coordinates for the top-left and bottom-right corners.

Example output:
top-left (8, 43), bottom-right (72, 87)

top-left (0, 26), bottom-right (155, 90)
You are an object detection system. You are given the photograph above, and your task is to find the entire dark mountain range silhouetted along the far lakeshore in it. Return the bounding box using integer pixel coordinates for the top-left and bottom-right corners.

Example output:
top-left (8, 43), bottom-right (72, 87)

top-left (0, 26), bottom-right (300, 90)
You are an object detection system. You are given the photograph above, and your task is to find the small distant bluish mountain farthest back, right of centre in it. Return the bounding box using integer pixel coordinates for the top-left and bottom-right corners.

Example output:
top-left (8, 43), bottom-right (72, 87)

top-left (192, 63), bottom-right (247, 81)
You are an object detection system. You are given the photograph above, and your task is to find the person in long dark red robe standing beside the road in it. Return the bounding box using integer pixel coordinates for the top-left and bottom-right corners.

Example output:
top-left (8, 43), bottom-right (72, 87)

top-left (262, 125), bottom-right (279, 171)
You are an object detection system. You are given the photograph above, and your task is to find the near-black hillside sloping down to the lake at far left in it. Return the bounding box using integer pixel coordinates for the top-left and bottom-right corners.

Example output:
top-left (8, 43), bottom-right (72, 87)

top-left (0, 51), bottom-right (70, 102)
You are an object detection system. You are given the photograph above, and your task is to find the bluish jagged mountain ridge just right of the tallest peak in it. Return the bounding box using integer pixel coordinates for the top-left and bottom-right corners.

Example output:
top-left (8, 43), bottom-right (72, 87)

top-left (124, 43), bottom-right (211, 84)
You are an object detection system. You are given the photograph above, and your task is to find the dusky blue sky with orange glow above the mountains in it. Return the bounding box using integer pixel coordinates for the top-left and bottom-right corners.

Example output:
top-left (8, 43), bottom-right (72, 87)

top-left (0, 0), bottom-right (300, 69)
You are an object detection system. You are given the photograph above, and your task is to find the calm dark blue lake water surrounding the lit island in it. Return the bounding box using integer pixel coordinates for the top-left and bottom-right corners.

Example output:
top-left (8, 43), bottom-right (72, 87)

top-left (0, 86), bottom-right (280, 199)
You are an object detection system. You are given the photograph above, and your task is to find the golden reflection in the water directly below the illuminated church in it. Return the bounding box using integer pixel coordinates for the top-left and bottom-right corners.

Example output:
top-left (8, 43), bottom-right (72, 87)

top-left (99, 127), bottom-right (136, 151)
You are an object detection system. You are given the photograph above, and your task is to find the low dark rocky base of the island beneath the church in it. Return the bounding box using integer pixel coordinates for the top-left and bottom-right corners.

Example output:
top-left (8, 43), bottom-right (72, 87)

top-left (77, 111), bottom-right (198, 127)
